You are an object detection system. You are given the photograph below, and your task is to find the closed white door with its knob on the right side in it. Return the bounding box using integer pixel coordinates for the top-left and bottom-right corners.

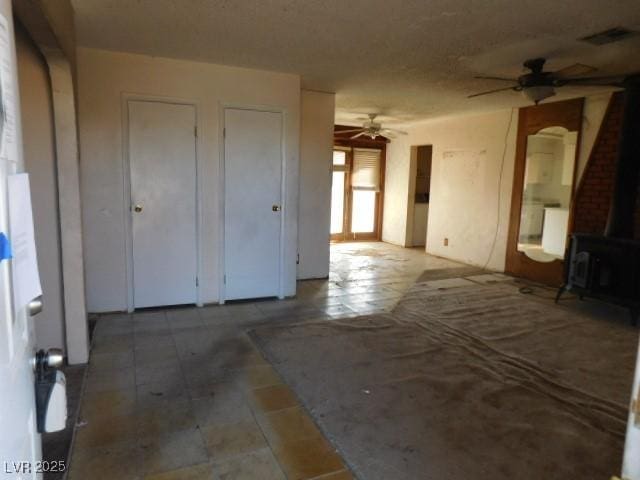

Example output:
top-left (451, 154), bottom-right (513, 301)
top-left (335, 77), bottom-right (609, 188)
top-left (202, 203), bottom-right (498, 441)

top-left (224, 108), bottom-right (283, 300)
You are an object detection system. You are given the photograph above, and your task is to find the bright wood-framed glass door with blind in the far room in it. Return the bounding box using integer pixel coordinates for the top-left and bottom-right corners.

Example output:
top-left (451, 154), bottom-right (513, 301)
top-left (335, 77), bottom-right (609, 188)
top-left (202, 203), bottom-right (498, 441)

top-left (331, 147), bottom-right (384, 241)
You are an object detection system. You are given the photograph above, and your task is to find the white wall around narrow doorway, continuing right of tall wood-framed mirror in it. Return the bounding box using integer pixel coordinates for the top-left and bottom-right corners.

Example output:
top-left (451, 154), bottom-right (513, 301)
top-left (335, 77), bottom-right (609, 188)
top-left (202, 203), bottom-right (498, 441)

top-left (382, 94), bottom-right (610, 270)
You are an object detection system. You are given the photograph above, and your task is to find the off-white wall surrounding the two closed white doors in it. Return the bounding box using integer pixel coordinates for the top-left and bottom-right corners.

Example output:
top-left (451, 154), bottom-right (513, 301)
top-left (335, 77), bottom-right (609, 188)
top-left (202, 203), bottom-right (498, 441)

top-left (77, 48), bottom-right (300, 312)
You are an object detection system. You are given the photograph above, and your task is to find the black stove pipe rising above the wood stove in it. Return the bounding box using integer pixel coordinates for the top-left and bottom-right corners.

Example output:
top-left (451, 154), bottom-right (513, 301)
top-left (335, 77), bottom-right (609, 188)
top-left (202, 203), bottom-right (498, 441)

top-left (605, 75), bottom-right (640, 238)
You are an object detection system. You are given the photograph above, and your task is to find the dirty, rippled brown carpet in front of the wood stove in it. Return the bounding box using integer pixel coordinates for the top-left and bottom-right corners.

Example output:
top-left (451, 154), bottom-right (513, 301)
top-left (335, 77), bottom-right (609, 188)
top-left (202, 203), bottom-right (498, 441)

top-left (251, 282), bottom-right (638, 480)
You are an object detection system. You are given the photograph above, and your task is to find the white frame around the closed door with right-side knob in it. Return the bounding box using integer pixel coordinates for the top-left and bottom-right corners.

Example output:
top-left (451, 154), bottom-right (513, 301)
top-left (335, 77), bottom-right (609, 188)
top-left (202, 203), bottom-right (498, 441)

top-left (218, 102), bottom-right (288, 305)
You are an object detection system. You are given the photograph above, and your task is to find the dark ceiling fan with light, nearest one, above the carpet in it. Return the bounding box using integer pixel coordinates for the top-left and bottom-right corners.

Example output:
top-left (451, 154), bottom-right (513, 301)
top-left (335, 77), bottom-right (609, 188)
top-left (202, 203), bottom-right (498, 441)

top-left (467, 58), bottom-right (624, 105)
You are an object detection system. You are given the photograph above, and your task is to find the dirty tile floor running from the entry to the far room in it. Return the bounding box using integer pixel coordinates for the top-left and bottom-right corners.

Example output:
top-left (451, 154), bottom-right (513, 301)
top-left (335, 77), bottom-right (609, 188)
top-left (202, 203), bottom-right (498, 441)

top-left (68, 243), bottom-right (459, 480)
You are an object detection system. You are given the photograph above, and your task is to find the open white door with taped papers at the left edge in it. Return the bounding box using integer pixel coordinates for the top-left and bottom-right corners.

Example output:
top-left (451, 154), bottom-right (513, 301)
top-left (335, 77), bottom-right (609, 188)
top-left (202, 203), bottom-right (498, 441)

top-left (0, 6), bottom-right (42, 479)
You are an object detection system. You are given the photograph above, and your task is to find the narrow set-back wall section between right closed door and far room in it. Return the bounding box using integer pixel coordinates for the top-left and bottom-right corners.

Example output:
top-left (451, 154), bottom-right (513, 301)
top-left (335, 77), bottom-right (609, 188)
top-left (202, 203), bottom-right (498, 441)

top-left (298, 90), bottom-right (335, 279)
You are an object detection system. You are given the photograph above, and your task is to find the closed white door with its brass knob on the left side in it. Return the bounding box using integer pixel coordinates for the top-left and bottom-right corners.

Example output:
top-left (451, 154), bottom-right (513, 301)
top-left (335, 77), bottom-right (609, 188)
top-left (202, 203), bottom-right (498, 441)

top-left (128, 100), bottom-right (197, 308)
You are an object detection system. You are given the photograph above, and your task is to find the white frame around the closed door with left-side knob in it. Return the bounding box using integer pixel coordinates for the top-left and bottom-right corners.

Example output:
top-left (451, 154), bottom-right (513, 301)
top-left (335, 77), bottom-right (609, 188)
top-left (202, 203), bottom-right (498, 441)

top-left (120, 92), bottom-right (203, 313)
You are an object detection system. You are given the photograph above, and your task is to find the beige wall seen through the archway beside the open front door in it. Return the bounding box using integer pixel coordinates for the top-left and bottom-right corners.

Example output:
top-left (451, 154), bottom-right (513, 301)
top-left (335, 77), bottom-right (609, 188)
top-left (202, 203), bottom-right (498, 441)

top-left (16, 28), bottom-right (65, 348)
